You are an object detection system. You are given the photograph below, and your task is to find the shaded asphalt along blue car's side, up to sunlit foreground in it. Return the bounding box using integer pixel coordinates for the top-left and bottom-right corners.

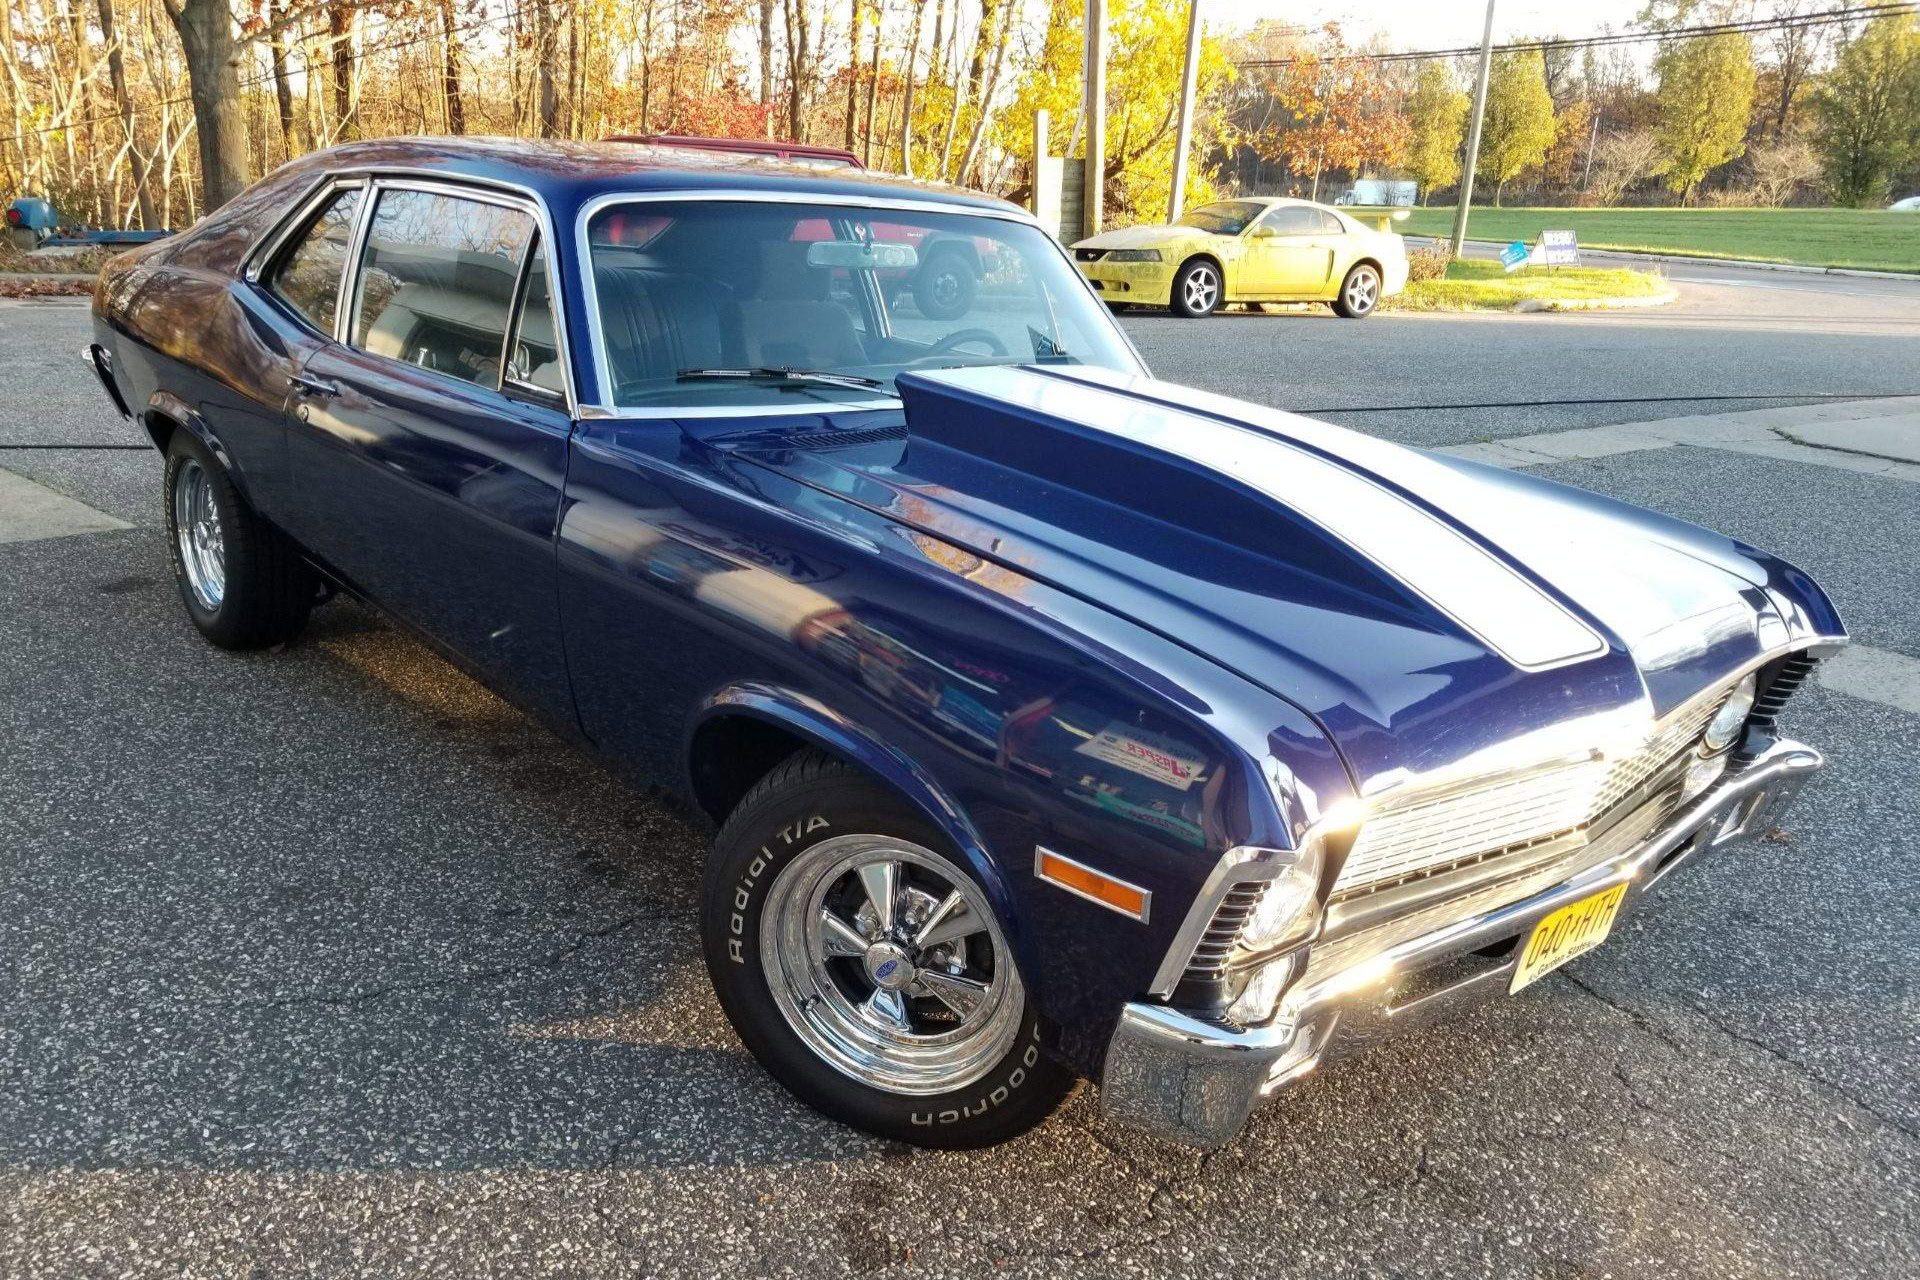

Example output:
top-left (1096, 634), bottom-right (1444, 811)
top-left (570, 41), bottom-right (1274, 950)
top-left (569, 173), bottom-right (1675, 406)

top-left (0, 530), bottom-right (898, 1169)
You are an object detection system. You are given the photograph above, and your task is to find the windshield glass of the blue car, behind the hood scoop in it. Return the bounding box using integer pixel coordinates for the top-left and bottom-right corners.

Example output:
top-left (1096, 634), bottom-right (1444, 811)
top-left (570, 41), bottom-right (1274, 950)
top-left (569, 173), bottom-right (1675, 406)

top-left (588, 200), bottom-right (1140, 409)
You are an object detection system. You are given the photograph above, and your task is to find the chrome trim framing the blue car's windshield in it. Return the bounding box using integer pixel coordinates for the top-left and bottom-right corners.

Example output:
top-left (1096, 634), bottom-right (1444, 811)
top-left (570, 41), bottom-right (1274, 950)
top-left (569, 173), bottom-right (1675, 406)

top-left (574, 188), bottom-right (1152, 420)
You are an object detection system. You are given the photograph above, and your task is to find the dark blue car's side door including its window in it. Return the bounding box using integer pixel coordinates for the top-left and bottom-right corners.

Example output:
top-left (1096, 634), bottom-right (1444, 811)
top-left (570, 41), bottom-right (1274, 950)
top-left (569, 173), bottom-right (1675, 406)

top-left (288, 180), bottom-right (572, 720)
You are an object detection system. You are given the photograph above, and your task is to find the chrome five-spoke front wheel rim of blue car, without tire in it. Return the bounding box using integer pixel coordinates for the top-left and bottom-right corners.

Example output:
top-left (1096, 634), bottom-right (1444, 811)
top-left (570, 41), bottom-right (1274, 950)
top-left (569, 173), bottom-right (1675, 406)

top-left (760, 835), bottom-right (1025, 1094)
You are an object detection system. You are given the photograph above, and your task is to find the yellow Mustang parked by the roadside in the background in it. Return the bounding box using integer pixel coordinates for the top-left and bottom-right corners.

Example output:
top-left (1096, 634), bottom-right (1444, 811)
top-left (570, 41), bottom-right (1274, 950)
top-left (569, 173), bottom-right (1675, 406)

top-left (1073, 196), bottom-right (1407, 320)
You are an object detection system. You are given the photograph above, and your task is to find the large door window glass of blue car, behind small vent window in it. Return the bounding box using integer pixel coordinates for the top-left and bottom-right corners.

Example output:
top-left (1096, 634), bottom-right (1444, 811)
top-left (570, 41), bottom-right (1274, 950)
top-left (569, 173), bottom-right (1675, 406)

top-left (353, 188), bottom-right (533, 386)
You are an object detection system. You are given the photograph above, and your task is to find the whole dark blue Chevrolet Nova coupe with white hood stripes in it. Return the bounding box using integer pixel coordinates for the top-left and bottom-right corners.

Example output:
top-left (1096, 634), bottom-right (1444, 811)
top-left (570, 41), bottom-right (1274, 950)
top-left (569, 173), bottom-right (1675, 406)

top-left (86, 140), bottom-right (1845, 1146)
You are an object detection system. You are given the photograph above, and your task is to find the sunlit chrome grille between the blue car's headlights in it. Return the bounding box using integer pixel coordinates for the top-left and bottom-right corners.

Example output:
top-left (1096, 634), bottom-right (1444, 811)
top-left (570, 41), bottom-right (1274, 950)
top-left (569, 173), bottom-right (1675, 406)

top-left (1334, 691), bottom-right (1726, 898)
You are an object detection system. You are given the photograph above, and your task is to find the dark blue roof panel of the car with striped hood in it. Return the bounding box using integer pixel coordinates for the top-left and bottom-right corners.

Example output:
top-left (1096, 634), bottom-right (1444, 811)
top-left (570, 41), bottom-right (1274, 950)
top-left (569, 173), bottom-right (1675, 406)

top-left (278, 138), bottom-right (1023, 213)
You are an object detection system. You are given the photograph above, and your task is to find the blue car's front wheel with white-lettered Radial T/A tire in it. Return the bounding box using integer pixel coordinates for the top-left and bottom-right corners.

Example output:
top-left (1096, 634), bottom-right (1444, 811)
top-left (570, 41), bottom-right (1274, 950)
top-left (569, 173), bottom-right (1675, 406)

top-left (701, 750), bottom-right (1073, 1148)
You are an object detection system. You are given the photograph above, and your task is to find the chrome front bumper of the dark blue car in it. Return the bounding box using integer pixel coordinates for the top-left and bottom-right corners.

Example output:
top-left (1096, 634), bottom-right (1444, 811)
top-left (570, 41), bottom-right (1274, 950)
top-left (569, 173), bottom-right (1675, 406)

top-left (1100, 739), bottom-right (1826, 1148)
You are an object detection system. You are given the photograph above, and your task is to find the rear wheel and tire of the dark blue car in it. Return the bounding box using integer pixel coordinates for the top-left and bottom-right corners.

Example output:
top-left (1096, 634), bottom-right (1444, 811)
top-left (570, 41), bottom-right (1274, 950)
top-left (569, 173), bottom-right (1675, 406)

top-left (163, 428), bottom-right (319, 649)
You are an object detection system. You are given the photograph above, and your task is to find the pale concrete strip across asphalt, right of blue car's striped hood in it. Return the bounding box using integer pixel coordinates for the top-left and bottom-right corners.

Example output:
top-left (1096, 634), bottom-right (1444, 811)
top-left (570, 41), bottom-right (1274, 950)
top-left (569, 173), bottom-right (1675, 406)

top-left (1434, 395), bottom-right (1920, 484)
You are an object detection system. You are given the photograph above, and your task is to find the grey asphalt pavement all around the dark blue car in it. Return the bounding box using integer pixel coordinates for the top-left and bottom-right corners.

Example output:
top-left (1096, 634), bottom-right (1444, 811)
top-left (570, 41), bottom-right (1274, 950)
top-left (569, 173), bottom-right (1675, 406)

top-left (11, 282), bottom-right (1920, 1276)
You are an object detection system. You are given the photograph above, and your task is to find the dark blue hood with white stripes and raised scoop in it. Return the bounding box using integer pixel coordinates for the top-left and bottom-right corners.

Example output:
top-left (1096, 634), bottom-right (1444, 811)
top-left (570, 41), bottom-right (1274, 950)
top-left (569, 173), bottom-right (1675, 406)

top-left (721, 367), bottom-right (1843, 793)
